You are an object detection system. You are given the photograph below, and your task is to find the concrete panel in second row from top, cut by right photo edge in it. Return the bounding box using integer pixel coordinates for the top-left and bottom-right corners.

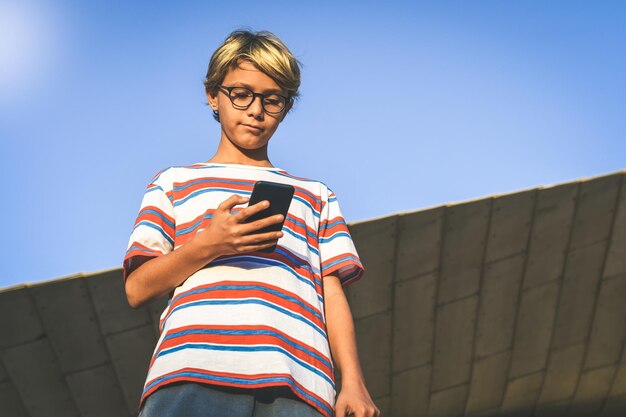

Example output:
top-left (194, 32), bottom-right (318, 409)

top-left (585, 274), bottom-right (626, 369)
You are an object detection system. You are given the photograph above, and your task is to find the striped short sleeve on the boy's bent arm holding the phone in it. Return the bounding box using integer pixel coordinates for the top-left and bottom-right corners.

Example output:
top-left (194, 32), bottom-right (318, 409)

top-left (123, 170), bottom-right (176, 282)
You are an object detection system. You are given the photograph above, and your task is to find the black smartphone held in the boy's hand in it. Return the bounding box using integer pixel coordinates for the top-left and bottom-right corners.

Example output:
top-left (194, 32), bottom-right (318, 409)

top-left (244, 181), bottom-right (295, 253)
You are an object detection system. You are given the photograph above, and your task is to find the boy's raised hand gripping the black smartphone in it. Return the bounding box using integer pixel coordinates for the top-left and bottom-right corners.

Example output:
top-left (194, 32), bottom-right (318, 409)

top-left (193, 194), bottom-right (283, 257)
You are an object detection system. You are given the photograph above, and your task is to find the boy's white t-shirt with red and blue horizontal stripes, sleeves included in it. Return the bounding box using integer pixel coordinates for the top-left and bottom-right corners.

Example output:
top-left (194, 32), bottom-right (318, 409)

top-left (123, 163), bottom-right (364, 417)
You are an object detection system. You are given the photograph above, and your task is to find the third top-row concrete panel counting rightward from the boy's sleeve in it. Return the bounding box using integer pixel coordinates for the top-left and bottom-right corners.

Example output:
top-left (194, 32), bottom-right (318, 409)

top-left (438, 199), bottom-right (491, 303)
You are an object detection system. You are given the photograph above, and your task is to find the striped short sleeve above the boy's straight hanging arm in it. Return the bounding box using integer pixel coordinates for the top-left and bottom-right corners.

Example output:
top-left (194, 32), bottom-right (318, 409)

top-left (317, 186), bottom-right (365, 287)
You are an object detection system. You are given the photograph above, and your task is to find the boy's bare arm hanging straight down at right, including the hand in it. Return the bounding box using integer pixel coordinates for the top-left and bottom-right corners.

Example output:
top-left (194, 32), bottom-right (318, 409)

top-left (323, 274), bottom-right (380, 417)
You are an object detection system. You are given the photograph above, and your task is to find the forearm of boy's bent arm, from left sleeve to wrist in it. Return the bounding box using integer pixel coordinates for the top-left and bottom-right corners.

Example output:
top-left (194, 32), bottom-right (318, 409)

top-left (126, 239), bottom-right (217, 308)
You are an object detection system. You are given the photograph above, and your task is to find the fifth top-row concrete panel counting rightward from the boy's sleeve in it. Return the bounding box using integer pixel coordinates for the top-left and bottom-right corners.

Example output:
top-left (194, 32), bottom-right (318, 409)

top-left (524, 184), bottom-right (579, 288)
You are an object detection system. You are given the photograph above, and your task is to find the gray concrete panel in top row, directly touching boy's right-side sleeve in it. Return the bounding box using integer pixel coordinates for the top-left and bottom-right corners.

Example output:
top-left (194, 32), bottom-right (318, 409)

top-left (346, 216), bottom-right (398, 319)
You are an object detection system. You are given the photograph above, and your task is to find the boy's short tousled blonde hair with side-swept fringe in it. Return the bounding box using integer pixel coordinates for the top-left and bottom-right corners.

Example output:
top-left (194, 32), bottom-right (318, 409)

top-left (204, 29), bottom-right (302, 121)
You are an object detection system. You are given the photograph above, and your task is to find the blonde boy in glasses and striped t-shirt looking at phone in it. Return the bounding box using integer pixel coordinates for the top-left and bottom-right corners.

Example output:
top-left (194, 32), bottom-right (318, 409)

top-left (124, 31), bottom-right (380, 417)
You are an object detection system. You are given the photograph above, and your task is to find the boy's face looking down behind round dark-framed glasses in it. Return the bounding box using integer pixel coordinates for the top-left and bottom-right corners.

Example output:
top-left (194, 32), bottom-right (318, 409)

top-left (207, 61), bottom-right (291, 150)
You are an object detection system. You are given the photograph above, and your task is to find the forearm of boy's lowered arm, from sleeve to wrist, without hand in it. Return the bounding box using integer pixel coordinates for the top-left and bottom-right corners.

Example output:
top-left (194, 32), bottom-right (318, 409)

top-left (324, 276), bottom-right (365, 386)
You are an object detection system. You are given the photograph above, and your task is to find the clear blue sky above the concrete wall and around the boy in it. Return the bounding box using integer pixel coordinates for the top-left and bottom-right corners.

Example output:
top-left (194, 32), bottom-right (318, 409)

top-left (0, 0), bottom-right (626, 287)
